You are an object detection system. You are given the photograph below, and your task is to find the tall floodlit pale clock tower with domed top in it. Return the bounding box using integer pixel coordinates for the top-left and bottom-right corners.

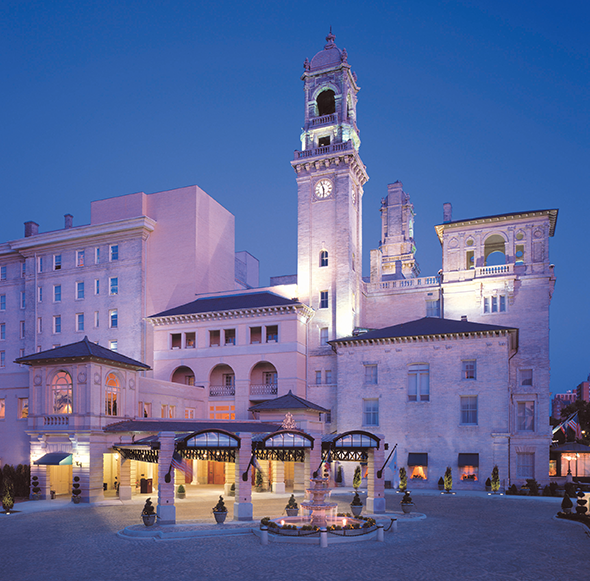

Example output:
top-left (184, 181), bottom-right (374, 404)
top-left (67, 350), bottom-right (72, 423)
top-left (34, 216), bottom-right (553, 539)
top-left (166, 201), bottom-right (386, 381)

top-left (291, 31), bottom-right (369, 362)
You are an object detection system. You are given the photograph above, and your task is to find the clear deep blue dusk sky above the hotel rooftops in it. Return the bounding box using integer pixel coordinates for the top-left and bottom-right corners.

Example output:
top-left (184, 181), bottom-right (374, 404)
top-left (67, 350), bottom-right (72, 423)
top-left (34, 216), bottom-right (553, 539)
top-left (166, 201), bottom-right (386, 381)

top-left (0, 0), bottom-right (590, 392)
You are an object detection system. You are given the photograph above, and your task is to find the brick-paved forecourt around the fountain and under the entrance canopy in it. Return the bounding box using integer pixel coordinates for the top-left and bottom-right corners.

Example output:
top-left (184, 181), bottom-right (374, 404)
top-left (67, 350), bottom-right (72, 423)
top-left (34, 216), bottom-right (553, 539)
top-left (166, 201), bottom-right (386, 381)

top-left (0, 487), bottom-right (590, 581)
